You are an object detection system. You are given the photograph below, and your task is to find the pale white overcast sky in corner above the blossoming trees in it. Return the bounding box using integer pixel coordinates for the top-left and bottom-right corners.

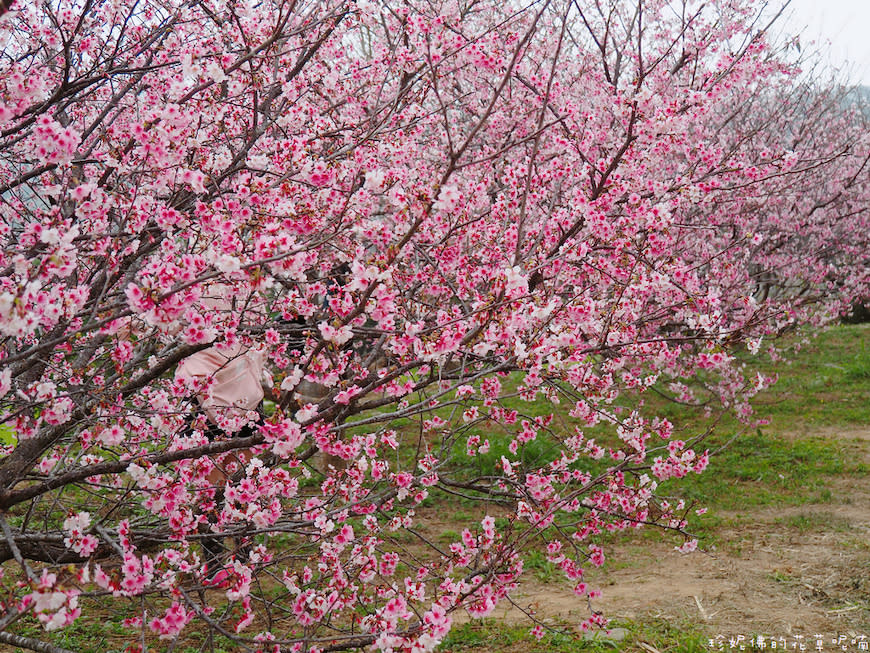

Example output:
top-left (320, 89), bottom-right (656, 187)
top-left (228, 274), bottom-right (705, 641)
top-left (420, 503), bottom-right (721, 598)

top-left (772, 0), bottom-right (870, 86)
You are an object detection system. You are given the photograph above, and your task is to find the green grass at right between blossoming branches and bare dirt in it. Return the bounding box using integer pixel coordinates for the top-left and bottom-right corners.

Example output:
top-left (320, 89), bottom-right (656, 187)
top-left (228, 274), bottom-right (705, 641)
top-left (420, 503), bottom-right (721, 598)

top-left (680, 325), bottom-right (870, 510)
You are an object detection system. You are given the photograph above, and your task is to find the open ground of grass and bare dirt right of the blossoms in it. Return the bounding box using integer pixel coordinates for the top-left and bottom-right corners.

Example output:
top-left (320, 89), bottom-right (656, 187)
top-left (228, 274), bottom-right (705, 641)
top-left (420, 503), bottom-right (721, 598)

top-left (443, 326), bottom-right (870, 653)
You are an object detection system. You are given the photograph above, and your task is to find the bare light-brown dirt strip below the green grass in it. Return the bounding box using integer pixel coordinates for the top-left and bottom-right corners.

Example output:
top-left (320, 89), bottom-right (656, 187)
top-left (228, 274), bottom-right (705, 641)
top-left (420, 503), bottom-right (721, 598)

top-left (495, 429), bottom-right (870, 636)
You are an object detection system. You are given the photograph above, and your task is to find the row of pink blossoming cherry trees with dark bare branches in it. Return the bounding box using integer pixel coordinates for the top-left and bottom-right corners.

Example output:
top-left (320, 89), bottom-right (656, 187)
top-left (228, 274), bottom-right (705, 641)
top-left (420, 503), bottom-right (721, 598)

top-left (0, 0), bottom-right (870, 651)
